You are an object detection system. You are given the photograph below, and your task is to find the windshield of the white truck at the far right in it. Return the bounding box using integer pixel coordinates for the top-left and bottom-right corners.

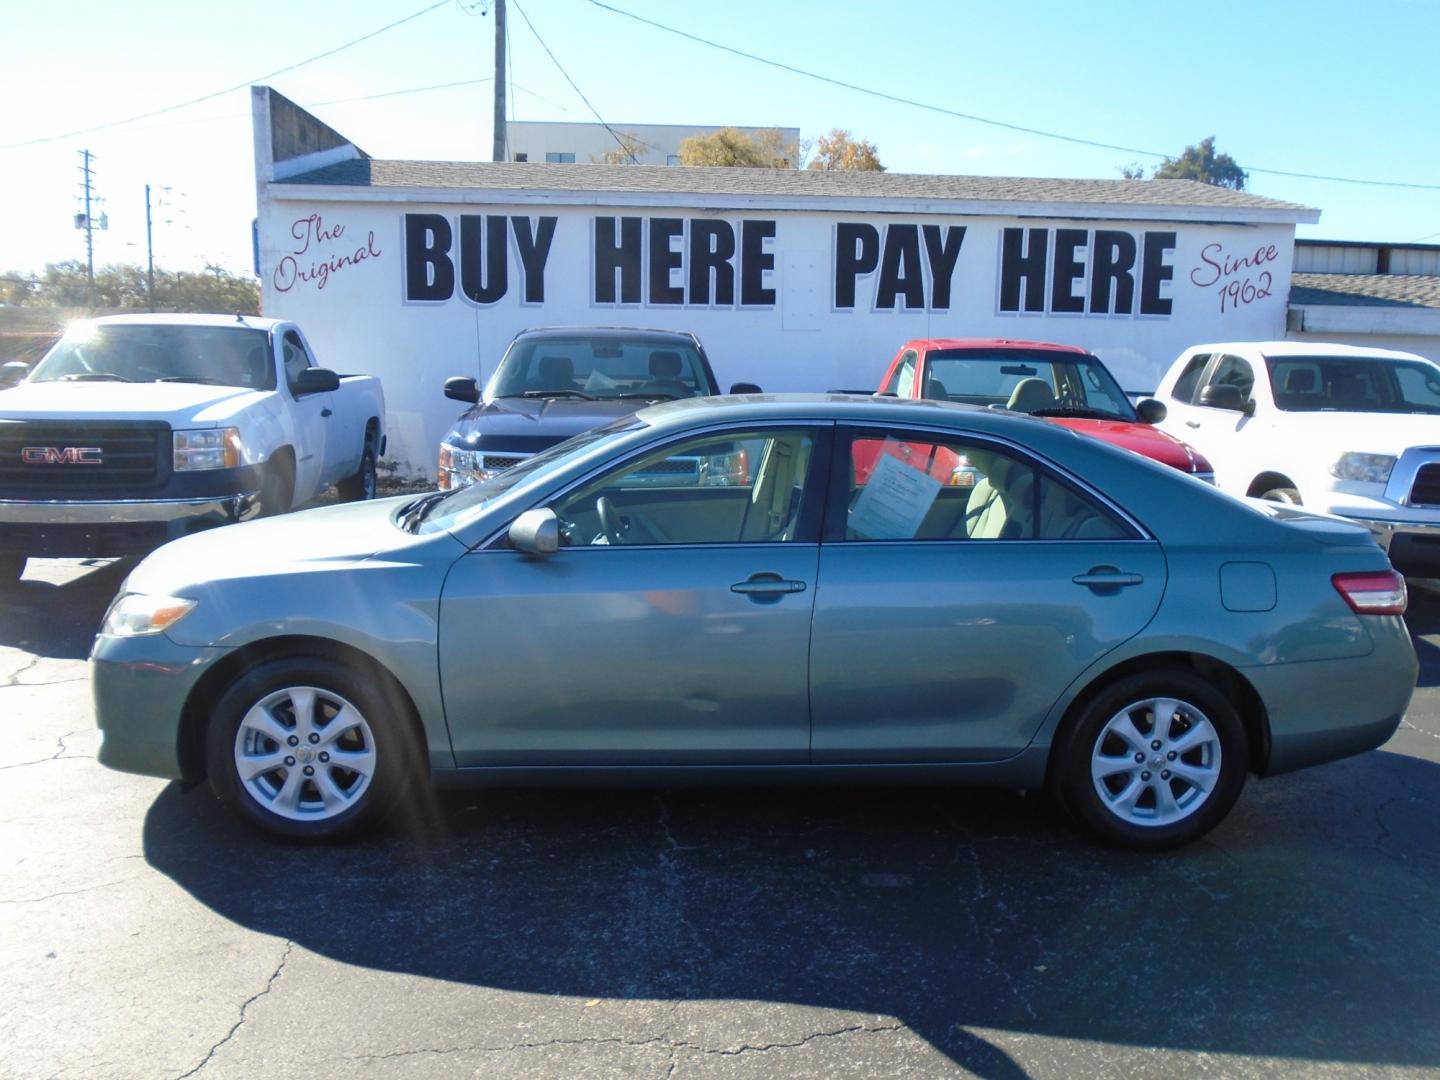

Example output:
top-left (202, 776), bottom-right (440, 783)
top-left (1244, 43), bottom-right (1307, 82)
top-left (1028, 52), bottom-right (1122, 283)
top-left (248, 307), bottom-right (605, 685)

top-left (1266, 356), bottom-right (1440, 413)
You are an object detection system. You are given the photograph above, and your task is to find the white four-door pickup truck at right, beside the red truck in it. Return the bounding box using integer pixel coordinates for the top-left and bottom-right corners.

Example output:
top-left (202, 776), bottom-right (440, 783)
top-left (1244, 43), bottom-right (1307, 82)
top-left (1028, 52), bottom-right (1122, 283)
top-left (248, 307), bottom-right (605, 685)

top-left (1155, 341), bottom-right (1440, 577)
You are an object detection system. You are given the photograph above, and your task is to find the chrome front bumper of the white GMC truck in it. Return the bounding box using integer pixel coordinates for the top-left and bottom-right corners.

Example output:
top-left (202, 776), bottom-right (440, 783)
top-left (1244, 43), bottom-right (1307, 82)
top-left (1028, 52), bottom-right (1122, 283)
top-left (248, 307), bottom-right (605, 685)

top-left (0, 491), bottom-right (259, 557)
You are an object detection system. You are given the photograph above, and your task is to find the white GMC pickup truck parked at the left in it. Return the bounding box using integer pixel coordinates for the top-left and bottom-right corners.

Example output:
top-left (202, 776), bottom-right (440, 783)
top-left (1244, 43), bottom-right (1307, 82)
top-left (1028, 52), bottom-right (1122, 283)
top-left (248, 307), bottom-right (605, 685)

top-left (0, 315), bottom-right (386, 583)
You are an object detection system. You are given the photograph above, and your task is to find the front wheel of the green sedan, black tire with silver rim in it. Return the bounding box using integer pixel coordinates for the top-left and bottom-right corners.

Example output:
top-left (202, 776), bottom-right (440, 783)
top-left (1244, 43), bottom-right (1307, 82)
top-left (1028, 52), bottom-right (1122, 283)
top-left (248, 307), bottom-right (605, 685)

top-left (204, 657), bottom-right (422, 841)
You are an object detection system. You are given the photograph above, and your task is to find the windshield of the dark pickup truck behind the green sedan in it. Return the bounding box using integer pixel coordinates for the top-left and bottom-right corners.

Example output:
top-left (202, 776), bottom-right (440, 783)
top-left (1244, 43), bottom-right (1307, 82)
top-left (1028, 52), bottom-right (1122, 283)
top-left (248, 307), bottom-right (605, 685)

top-left (485, 336), bottom-right (716, 400)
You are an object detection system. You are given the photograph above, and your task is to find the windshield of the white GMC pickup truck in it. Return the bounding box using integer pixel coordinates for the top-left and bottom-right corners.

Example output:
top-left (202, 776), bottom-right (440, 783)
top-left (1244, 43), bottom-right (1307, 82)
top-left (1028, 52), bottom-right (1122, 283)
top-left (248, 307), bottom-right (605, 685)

top-left (30, 324), bottom-right (275, 390)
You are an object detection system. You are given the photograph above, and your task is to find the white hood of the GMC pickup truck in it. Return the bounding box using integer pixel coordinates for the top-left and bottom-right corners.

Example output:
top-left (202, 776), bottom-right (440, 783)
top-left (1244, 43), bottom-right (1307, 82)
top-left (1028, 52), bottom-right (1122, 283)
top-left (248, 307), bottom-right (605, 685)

top-left (0, 382), bottom-right (261, 426)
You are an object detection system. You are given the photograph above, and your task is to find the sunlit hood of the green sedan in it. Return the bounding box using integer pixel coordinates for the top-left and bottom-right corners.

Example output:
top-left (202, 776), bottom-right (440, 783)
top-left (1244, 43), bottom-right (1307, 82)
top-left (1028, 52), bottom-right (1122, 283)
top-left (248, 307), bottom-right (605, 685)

top-left (124, 495), bottom-right (428, 596)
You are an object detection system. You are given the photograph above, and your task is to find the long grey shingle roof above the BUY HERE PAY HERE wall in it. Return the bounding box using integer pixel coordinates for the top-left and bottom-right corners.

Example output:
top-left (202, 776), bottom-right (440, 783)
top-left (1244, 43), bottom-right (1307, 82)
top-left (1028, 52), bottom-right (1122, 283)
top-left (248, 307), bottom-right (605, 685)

top-left (285, 158), bottom-right (1313, 215)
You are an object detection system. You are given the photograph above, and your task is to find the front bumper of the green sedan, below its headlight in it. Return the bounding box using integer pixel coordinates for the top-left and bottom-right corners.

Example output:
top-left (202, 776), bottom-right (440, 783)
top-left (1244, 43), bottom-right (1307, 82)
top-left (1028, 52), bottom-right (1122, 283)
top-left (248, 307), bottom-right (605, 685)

top-left (91, 634), bottom-right (228, 779)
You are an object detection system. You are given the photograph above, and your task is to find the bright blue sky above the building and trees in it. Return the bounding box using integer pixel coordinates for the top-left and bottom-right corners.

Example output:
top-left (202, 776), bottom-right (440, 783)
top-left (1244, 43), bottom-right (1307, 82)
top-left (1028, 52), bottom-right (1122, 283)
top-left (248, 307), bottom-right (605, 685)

top-left (0, 0), bottom-right (1440, 271)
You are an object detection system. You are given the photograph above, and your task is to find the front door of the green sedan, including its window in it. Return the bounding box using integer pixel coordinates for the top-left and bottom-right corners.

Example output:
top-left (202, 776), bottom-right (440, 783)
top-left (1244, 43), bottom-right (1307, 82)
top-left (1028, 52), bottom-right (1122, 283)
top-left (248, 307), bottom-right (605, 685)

top-left (439, 425), bottom-right (831, 766)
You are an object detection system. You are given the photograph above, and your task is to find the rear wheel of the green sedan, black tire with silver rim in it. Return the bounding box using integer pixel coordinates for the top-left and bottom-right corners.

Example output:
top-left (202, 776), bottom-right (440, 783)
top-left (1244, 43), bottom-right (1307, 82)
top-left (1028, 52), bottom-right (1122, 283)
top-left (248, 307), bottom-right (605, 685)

top-left (1051, 670), bottom-right (1250, 851)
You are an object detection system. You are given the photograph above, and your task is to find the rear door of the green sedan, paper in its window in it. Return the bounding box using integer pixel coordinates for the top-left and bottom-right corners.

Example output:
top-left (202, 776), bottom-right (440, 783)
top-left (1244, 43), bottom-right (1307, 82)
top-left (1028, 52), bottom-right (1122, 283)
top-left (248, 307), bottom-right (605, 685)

top-left (811, 426), bottom-right (1165, 763)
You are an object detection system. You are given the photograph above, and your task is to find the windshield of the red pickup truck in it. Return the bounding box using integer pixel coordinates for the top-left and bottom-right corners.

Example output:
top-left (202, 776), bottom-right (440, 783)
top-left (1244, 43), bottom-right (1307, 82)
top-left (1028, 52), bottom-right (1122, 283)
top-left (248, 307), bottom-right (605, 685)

top-left (922, 348), bottom-right (1136, 422)
